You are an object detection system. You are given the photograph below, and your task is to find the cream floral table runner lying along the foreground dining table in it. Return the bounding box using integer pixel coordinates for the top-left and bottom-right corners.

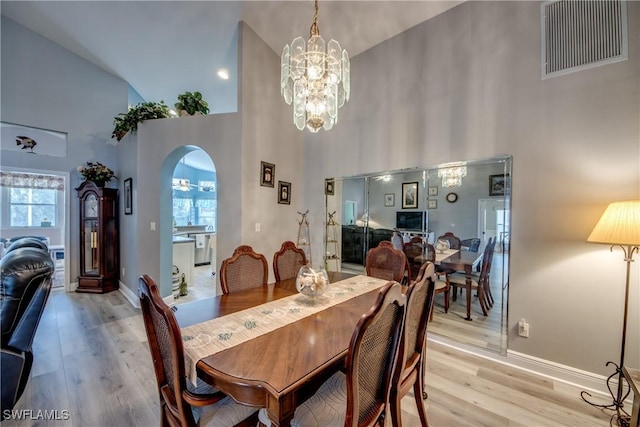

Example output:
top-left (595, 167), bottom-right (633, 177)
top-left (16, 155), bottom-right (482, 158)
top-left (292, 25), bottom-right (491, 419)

top-left (181, 275), bottom-right (388, 384)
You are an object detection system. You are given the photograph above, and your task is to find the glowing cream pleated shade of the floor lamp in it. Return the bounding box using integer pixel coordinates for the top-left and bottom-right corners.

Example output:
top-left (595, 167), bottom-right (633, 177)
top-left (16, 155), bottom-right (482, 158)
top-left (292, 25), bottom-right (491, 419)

top-left (587, 200), bottom-right (640, 246)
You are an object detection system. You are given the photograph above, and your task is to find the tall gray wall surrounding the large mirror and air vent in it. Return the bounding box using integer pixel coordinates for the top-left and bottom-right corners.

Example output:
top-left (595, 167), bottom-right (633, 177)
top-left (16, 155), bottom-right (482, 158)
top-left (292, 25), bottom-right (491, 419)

top-left (305, 1), bottom-right (640, 374)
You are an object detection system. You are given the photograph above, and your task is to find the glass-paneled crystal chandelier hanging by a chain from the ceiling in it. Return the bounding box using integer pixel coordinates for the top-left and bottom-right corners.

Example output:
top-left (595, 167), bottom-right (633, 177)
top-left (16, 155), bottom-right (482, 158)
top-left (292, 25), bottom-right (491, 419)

top-left (280, 0), bottom-right (351, 133)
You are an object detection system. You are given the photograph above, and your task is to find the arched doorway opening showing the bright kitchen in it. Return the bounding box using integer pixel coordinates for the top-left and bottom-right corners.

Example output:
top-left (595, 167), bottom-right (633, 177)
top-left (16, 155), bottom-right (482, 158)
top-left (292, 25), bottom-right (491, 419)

top-left (171, 146), bottom-right (217, 304)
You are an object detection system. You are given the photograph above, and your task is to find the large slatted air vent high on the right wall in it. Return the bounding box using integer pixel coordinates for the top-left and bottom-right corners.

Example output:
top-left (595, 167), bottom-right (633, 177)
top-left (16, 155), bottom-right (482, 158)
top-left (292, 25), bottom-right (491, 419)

top-left (542, 0), bottom-right (629, 79)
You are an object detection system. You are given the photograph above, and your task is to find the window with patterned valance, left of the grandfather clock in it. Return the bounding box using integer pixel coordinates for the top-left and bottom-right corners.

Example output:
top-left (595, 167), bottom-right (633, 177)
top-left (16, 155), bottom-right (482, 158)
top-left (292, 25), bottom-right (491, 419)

top-left (0, 171), bottom-right (64, 228)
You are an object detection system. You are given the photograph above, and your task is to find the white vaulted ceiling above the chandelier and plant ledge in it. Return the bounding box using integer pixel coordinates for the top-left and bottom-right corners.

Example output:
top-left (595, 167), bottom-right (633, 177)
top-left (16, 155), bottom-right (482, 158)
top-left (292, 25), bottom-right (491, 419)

top-left (0, 0), bottom-right (462, 112)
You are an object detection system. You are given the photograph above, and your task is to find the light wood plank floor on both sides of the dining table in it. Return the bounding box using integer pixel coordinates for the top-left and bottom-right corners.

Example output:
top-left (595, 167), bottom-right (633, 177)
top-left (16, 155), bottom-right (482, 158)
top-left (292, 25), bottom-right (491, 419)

top-left (2, 291), bottom-right (609, 427)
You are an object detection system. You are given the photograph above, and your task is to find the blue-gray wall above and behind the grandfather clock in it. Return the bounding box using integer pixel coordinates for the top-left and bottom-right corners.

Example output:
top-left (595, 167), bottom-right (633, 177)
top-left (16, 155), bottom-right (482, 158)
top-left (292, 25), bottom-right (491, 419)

top-left (0, 17), bottom-right (128, 282)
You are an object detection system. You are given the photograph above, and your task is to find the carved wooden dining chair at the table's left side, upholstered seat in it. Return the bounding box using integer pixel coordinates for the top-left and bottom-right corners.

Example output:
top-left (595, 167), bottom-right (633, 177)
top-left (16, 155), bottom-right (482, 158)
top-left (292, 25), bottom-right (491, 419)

top-left (139, 275), bottom-right (257, 427)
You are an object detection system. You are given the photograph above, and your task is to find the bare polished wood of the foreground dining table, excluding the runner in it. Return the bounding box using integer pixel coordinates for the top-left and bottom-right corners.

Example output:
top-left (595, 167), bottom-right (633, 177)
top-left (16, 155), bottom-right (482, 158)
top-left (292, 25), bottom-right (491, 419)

top-left (175, 272), bottom-right (386, 426)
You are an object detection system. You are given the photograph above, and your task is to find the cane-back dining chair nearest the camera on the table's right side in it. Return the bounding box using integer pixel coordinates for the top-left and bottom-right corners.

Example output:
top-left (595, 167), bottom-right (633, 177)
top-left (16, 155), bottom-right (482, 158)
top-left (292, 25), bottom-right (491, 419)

top-left (259, 282), bottom-right (406, 427)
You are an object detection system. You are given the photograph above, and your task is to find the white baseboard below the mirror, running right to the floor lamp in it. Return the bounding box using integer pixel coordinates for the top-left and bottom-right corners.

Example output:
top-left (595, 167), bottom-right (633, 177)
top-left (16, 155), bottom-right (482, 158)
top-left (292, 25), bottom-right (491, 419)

top-left (428, 334), bottom-right (631, 405)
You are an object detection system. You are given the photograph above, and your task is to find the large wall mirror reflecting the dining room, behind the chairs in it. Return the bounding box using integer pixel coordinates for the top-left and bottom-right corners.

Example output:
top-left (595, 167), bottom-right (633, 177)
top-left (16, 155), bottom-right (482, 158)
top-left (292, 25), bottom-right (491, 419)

top-left (325, 156), bottom-right (512, 354)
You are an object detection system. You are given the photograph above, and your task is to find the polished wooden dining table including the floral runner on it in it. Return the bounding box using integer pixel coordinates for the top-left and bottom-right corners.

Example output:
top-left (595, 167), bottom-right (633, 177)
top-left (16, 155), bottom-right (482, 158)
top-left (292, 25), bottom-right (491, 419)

top-left (175, 272), bottom-right (387, 426)
